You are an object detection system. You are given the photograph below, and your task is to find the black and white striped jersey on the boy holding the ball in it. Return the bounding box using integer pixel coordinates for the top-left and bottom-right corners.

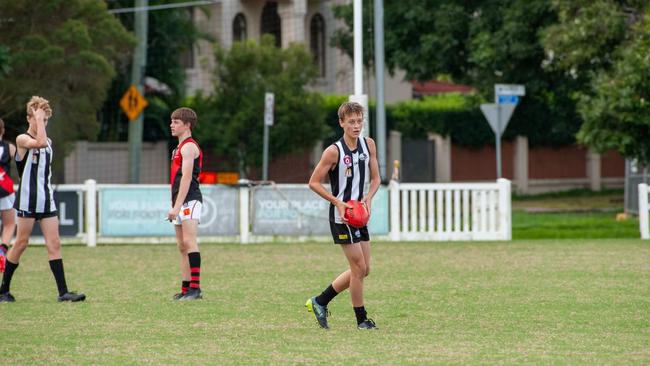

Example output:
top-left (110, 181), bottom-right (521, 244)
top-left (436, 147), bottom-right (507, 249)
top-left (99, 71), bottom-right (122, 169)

top-left (329, 138), bottom-right (370, 224)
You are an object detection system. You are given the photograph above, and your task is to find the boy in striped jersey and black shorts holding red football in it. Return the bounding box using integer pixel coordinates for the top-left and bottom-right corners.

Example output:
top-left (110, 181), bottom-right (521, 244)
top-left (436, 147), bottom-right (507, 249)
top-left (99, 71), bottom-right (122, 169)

top-left (305, 102), bottom-right (380, 329)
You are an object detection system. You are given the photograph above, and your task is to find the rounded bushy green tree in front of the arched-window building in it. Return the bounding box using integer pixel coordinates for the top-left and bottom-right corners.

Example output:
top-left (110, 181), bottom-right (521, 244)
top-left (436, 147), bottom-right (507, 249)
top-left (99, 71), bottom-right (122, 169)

top-left (194, 35), bottom-right (326, 176)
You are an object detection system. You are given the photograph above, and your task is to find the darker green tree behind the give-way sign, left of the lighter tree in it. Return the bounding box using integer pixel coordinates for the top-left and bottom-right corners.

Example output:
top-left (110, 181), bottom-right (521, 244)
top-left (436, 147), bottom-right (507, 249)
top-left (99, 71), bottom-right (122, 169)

top-left (337, 0), bottom-right (581, 145)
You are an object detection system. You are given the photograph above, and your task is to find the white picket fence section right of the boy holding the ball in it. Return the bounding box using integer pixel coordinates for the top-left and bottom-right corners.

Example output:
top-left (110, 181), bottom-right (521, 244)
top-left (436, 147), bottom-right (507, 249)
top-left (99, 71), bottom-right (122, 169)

top-left (390, 179), bottom-right (512, 241)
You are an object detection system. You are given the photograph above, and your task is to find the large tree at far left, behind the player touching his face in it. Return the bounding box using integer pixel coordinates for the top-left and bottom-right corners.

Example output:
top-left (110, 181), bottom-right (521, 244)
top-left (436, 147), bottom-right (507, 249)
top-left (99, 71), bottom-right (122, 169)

top-left (0, 0), bottom-right (133, 155)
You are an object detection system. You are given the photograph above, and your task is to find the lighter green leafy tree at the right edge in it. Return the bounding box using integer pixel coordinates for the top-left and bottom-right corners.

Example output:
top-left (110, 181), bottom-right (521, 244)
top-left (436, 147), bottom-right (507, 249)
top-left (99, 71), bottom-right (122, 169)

top-left (545, 0), bottom-right (650, 164)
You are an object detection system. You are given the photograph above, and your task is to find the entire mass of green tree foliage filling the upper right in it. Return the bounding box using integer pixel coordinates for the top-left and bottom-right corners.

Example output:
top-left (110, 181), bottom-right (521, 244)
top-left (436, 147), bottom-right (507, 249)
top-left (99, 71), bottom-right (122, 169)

top-left (335, 0), bottom-right (650, 162)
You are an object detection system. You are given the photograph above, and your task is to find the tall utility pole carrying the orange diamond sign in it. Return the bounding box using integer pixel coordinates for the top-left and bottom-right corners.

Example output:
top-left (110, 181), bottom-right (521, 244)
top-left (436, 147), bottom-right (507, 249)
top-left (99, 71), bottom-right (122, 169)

top-left (129, 0), bottom-right (149, 183)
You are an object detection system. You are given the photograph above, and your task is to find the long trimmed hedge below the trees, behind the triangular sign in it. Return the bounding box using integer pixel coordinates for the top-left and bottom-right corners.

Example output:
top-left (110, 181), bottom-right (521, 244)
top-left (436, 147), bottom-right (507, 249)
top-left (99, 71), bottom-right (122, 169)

top-left (324, 93), bottom-right (579, 147)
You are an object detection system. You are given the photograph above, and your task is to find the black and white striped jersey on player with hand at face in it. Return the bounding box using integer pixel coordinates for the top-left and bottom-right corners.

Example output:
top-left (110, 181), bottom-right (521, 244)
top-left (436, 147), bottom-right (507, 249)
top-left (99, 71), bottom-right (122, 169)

top-left (14, 134), bottom-right (56, 213)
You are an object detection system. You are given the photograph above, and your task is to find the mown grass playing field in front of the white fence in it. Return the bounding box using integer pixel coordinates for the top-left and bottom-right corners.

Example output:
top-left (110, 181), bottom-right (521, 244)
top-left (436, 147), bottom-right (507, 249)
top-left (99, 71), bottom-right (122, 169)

top-left (0, 239), bottom-right (650, 365)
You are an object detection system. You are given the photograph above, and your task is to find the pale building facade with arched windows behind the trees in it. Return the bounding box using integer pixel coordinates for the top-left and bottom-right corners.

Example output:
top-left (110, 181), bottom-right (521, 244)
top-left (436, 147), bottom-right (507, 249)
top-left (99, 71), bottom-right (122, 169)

top-left (186, 0), bottom-right (412, 102)
